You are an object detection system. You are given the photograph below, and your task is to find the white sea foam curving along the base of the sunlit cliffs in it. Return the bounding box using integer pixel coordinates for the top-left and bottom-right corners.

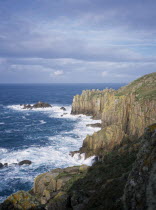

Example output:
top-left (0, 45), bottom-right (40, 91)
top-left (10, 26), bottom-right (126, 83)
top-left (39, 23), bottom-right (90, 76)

top-left (1, 105), bottom-right (101, 169)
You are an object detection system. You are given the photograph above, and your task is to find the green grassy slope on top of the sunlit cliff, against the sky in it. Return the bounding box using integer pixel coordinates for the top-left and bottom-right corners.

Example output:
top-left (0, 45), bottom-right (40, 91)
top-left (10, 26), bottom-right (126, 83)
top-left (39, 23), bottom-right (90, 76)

top-left (116, 72), bottom-right (156, 99)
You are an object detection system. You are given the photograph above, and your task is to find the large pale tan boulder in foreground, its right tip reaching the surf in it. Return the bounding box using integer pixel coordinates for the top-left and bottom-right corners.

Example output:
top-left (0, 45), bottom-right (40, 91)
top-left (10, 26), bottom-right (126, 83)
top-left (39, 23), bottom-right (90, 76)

top-left (33, 165), bottom-right (89, 204)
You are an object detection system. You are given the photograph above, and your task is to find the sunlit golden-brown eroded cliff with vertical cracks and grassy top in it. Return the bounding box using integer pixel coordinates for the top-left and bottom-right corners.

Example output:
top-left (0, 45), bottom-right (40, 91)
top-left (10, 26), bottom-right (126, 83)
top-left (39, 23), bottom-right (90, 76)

top-left (72, 73), bottom-right (156, 157)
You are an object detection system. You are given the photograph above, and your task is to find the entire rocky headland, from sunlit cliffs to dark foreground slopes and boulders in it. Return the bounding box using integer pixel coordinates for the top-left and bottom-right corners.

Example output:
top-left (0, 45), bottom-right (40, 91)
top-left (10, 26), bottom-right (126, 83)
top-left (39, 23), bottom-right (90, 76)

top-left (0, 73), bottom-right (156, 210)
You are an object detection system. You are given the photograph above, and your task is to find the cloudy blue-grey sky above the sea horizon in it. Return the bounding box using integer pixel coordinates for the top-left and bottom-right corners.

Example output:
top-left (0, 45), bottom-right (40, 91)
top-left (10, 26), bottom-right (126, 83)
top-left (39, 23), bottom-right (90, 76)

top-left (0, 0), bottom-right (156, 83)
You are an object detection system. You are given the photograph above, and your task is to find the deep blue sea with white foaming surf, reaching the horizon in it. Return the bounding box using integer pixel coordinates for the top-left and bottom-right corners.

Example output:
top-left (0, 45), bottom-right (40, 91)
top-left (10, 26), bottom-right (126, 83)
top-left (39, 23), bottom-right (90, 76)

top-left (0, 84), bottom-right (123, 202)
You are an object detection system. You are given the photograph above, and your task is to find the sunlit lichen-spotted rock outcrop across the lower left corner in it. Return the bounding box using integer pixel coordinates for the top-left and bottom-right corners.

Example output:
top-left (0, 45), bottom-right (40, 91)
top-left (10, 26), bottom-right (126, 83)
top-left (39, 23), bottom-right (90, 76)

top-left (0, 165), bottom-right (89, 210)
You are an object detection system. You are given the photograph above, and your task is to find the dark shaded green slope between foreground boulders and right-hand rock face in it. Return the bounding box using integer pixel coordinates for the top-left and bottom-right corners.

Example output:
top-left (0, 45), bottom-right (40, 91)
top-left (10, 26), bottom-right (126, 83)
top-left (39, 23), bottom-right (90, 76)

top-left (68, 137), bottom-right (139, 210)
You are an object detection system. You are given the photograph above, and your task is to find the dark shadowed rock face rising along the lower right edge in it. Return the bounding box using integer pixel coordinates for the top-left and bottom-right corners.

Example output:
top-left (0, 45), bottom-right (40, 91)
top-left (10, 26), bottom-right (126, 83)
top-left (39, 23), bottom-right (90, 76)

top-left (123, 124), bottom-right (156, 210)
